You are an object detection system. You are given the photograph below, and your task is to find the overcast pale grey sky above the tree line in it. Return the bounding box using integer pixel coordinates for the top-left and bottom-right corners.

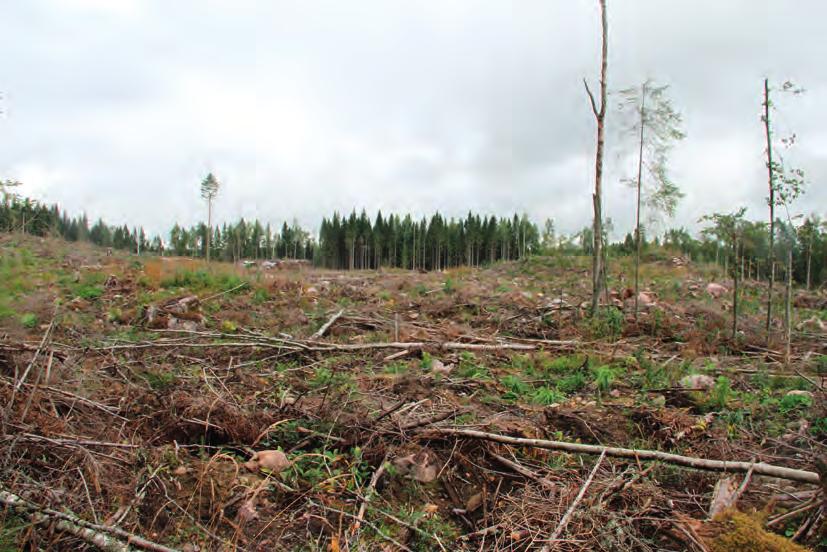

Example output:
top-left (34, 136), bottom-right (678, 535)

top-left (0, 0), bottom-right (827, 239)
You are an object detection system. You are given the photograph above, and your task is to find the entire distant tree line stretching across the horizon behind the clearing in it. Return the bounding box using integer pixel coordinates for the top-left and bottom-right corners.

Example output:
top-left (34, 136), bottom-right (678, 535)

top-left (0, 181), bottom-right (827, 287)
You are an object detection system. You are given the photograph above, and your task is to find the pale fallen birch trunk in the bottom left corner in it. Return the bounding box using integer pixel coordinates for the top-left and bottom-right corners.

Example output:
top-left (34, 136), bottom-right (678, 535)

top-left (0, 489), bottom-right (177, 552)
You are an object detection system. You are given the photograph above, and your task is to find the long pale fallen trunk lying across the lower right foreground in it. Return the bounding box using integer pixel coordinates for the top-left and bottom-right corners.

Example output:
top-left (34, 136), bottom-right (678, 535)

top-left (429, 428), bottom-right (820, 485)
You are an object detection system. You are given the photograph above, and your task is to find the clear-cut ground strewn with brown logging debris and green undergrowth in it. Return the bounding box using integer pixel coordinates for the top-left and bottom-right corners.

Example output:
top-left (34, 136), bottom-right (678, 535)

top-left (0, 236), bottom-right (827, 551)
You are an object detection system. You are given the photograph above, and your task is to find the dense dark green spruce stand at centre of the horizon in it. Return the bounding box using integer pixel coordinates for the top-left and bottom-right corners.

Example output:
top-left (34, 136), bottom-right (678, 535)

top-left (315, 211), bottom-right (540, 270)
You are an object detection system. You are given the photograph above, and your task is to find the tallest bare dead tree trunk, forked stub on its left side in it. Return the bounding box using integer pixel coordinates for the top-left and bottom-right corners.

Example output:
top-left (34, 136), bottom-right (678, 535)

top-left (583, 0), bottom-right (609, 315)
